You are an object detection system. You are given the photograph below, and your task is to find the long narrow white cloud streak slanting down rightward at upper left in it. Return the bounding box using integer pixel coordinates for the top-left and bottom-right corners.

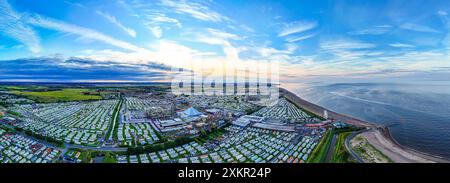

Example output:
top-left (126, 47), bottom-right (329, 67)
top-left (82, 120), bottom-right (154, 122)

top-left (28, 15), bottom-right (145, 51)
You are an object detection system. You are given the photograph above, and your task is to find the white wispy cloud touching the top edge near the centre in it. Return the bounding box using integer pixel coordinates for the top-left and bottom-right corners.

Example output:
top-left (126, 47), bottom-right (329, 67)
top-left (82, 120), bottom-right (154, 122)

top-left (161, 0), bottom-right (229, 22)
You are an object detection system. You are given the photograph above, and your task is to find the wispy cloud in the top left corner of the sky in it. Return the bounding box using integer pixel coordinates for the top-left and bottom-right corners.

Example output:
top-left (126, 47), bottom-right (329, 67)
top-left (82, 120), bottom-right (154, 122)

top-left (0, 0), bottom-right (41, 53)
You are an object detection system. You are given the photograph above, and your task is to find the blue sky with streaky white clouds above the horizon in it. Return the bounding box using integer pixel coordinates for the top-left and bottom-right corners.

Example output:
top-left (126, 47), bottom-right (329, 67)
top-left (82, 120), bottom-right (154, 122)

top-left (0, 0), bottom-right (450, 83)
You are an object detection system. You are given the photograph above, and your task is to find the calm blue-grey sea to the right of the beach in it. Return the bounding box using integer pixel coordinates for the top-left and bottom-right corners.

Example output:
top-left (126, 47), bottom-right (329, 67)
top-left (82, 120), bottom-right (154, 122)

top-left (282, 82), bottom-right (450, 159)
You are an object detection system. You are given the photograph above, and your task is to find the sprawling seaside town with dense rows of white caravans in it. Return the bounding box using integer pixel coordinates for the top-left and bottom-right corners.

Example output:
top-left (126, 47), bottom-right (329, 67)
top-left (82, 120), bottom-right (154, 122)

top-left (0, 85), bottom-right (358, 163)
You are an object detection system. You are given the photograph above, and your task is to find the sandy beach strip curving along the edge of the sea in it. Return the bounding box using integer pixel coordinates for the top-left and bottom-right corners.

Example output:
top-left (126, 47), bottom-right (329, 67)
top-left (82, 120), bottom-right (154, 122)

top-left (280, 87), bottom-right (450, 163)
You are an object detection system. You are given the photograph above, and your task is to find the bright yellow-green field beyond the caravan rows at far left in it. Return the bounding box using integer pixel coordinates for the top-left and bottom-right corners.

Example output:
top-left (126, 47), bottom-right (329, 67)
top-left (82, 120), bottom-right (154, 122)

top-left (14, 89), bottom-right (102, 103)
